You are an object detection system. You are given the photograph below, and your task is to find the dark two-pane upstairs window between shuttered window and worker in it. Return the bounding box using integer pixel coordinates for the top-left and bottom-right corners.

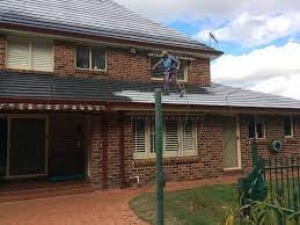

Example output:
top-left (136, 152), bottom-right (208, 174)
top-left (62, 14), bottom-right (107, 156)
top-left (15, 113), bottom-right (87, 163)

top-left (76, 45), bottom-right (106, 70)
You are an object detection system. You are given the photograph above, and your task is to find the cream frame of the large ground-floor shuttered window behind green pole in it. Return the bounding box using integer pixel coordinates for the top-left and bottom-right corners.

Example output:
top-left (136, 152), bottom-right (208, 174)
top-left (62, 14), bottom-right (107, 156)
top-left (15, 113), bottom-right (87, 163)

top-left (133, 118), bottom-right (198, 159)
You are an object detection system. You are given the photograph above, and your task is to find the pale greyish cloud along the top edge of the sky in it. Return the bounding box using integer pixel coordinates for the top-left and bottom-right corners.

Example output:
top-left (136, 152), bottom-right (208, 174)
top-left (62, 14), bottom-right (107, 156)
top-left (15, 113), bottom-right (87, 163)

top-left (114, 0), bottom-right (300, 20)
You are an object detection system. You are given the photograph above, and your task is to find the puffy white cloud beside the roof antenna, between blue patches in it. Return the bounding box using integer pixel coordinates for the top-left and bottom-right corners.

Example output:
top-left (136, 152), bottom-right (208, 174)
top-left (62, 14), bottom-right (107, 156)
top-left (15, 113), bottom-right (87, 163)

top-left (195, 11), bottom-right (300, 46)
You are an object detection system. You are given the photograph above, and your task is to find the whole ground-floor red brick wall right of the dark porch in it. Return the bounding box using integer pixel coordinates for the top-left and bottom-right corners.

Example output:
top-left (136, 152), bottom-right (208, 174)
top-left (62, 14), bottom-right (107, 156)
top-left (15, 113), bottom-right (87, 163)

top-left (96, 114), bottom-right (300, 187)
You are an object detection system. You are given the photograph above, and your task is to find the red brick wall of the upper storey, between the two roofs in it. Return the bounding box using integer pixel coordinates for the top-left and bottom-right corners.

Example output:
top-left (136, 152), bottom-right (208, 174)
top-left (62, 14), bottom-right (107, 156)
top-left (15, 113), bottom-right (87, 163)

top-left (0, 34), bottom-right (211, 86)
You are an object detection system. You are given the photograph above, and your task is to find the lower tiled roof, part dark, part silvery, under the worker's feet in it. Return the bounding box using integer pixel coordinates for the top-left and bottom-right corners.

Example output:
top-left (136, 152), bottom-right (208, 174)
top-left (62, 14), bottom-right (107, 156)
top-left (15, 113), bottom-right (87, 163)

top-left (0, 72), bottom-right (300, 109)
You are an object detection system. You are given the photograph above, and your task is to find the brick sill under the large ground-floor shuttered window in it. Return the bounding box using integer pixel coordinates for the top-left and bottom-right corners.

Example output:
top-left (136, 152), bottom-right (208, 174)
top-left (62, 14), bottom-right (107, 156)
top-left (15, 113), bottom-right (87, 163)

top-left (134, 155), bottom-right (199, 166)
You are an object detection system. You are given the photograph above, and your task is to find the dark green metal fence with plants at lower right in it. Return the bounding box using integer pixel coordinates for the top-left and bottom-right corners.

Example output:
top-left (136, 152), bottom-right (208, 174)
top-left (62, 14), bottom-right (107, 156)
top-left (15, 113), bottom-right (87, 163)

top-left (238, 141), bottom-right (300, 225)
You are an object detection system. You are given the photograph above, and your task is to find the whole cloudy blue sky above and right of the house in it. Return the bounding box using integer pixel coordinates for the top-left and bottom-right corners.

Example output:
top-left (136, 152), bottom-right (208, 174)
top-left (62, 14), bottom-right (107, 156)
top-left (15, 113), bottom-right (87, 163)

top-left (115, 0), bottom-right (300, 99)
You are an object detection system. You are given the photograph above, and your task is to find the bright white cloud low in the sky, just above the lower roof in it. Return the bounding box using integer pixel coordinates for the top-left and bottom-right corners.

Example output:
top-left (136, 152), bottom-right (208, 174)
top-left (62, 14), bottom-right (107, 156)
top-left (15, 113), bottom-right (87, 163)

top-left (212, 42), bottom-right (300, 99)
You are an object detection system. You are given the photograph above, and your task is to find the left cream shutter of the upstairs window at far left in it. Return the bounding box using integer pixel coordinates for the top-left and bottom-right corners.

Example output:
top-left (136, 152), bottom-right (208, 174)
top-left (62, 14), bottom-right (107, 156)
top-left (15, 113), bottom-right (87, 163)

top-left (7, 39), bottom-right (30, 70)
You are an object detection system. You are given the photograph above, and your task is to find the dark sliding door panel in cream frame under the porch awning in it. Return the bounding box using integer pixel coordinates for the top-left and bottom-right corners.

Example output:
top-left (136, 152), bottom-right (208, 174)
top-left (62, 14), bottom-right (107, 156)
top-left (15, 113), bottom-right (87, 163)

top-left (8, 118), bottom-right (46, 177)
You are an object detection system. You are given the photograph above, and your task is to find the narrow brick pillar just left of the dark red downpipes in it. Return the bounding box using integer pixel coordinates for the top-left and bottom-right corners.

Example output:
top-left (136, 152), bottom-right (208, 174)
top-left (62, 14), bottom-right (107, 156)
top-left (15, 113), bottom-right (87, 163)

top-left (89, 115), bottom-right (103, 189)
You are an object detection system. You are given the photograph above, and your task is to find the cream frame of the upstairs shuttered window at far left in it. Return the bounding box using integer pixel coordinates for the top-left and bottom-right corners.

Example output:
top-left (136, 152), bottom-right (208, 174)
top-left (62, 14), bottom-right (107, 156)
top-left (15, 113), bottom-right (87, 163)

top-left (5, 36), bottom-right (54, 73)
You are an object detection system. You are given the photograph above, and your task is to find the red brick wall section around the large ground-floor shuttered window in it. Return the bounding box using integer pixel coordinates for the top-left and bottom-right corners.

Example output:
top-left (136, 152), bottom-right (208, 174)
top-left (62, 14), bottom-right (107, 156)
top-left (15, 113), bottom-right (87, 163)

top-left (120, 116), bottom-right (223, 185)
